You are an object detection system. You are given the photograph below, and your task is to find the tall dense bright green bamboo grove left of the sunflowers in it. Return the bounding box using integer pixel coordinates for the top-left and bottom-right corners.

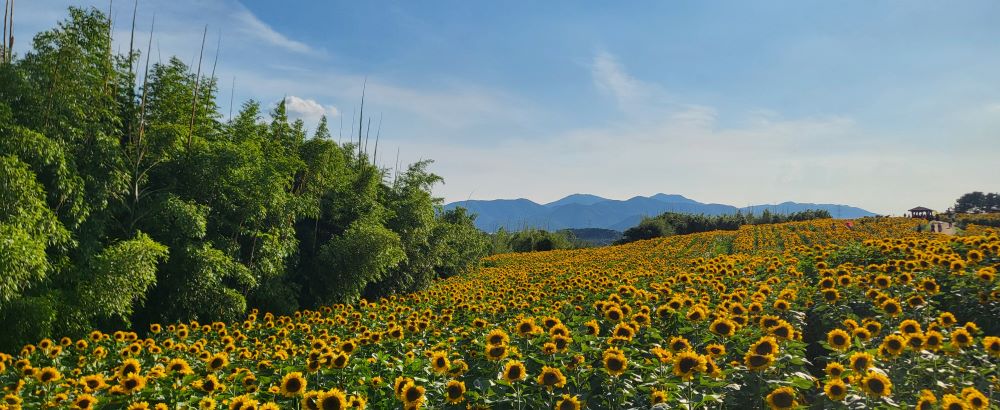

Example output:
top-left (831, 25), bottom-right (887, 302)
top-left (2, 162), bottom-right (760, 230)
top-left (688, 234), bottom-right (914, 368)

top-left (0, 8), bottom-right (490, 352)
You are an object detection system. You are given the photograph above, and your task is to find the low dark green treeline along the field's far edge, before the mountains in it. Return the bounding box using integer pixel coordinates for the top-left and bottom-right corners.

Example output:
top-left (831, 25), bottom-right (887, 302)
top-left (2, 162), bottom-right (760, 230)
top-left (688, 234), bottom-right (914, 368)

top-left (617, 209), bottom-right (831, 244)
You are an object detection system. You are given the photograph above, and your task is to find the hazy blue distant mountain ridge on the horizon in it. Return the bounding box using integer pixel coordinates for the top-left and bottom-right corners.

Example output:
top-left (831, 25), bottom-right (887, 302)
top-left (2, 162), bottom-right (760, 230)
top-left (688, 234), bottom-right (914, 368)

top-left (445, 193), bottom-right (875, 232)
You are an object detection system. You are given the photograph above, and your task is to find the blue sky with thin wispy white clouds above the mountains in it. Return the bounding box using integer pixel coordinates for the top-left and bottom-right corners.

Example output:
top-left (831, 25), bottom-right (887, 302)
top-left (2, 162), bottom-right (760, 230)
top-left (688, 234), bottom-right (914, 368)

top-left (16, 0), bottom-right (1000, 214)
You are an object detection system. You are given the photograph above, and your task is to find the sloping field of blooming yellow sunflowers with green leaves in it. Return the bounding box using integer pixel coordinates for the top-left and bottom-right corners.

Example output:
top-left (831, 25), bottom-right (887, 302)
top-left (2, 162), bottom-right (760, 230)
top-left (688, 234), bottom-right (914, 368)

top-left (0, 218), bottom-right (1000, 410)
